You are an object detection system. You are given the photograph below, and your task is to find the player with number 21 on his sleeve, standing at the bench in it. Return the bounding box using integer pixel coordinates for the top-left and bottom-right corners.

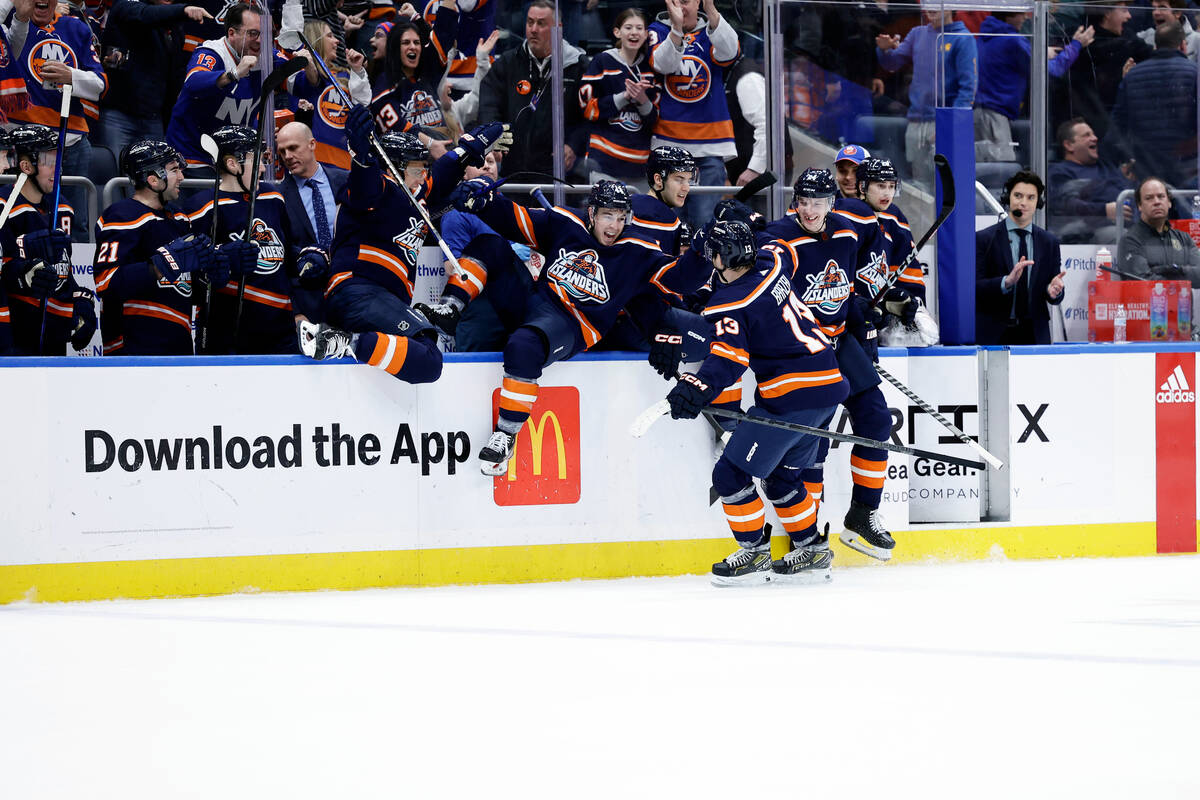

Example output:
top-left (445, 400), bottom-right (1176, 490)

top-left (95, 139), bottom-right (258, 355)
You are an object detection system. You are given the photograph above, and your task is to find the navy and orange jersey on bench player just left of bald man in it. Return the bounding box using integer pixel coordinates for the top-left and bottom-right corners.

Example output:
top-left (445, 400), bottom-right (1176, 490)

top-left (184, 184), bottom-right (301, 353)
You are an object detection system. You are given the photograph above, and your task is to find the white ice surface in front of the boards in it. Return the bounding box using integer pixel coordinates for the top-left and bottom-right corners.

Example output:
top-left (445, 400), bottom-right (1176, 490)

top-left (0, 557), bottom-right (1200, 800)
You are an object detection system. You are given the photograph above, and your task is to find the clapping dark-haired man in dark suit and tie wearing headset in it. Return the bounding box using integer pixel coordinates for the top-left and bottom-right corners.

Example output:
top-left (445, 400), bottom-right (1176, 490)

top-left (976, 169), bottom-right (1066, 344)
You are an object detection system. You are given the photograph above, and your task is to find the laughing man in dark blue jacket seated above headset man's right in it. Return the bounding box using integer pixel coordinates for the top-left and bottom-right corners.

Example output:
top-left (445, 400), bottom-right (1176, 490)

top-left (1046, 116), bottom-right (1133, 245)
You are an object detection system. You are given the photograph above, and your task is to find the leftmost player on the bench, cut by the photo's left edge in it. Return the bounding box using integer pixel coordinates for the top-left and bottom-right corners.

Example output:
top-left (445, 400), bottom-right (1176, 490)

top-left (0, 125), bottom-right (97, 355)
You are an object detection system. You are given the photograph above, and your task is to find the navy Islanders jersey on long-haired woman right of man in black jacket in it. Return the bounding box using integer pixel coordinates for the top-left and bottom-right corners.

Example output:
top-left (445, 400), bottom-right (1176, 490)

top-left (580, 48), bottom-right (659, 178)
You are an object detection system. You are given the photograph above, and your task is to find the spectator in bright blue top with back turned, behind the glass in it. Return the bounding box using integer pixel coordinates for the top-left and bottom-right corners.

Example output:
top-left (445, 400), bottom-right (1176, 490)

top-left (875, 6), bottom-right (978, 184)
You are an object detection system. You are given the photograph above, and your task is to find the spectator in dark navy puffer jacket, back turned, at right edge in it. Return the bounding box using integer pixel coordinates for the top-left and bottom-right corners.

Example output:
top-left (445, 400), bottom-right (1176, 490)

top-left (1105, 22), bottom-right (1198, 187)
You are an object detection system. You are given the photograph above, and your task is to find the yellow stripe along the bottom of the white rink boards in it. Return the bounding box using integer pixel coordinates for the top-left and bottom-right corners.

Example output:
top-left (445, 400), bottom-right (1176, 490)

top-left (0, 522), bottom-right (1156, 603)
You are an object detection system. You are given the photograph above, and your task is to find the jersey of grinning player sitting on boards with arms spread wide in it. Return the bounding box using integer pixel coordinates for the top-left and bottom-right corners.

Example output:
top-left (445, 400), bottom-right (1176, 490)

top-left (479, 194), bottom-right (712, 348)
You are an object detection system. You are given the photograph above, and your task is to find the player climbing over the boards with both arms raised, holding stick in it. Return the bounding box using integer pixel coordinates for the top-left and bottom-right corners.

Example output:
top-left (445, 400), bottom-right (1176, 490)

top-left (300, 106), bottom-right (509, 384)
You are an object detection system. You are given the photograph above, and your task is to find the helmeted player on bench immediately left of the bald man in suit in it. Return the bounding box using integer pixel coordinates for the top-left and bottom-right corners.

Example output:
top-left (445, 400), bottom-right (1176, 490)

top-left (185, 125), bottom-right (329, 355)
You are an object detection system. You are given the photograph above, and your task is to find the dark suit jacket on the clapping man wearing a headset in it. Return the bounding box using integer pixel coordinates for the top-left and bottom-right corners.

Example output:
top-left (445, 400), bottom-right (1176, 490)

top-left (976, 221), bottom-right (1066, 344)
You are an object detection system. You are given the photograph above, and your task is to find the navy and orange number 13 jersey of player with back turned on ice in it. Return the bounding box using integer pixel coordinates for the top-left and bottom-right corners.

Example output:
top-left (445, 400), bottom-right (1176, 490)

top-left (696, 256), bottom-right (850, 414)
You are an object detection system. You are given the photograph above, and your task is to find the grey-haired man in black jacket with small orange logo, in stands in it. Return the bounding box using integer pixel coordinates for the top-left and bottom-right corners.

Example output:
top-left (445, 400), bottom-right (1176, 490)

top-left (479, 0), bottom-right (588, 182)
